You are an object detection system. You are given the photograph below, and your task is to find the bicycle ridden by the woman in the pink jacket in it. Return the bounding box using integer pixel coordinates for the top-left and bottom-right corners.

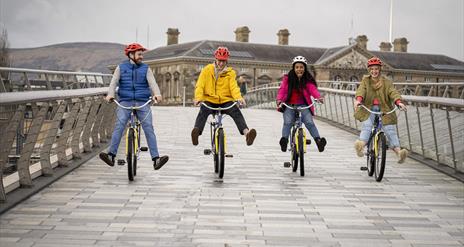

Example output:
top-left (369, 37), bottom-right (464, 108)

top-left (281, 99), bottom-right (318, 177)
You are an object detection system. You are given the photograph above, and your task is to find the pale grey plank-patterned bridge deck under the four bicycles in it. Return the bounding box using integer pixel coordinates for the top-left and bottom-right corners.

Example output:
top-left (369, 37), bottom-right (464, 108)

top-left (0, 107), bottom-right (464, 247)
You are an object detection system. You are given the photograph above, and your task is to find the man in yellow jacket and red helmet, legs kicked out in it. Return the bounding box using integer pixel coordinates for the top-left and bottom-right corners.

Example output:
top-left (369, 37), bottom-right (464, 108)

top-left (191, 47), bottom-right (256, 146)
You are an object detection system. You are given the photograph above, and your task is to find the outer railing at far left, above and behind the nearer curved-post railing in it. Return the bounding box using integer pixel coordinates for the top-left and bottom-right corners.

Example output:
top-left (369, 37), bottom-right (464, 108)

top-left (0, 67), bottom-right (112, 93)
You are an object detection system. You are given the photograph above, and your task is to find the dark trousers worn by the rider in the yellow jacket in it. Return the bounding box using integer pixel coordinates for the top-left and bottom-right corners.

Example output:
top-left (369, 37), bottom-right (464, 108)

top-left (194, 102), bottom-right (248, 135)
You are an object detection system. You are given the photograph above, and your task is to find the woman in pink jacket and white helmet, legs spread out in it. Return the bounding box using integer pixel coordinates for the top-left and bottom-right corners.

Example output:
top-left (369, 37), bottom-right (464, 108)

top-left (277, 56), bottom-right (327, 152)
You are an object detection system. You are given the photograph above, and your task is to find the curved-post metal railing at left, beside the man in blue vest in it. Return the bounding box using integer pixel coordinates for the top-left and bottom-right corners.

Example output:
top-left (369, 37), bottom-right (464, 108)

top-left (0, 88), bottom-right (115, 201)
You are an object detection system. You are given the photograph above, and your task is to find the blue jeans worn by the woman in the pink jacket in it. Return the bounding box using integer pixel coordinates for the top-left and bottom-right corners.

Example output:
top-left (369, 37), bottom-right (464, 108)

top-left (282, 105), bottom-right (320, 138)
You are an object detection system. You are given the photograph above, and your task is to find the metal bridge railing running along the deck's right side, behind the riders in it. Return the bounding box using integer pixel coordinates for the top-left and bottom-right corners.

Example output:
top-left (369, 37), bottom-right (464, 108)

top-left (245, 86), bottom-right (464, 173)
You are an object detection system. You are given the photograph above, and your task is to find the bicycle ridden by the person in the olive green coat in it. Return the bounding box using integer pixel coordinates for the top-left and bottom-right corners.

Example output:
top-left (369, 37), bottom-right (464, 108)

top-left (358, 104), bottom-right (398, 182)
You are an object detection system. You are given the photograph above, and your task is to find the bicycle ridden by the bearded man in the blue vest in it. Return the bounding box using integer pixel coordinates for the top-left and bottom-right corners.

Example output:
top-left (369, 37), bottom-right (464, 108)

top-left (112, 97), bottom-right (156, 181)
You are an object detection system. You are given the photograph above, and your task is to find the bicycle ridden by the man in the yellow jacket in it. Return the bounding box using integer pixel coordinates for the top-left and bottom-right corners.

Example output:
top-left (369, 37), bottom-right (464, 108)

top-left (201, 102), bottom-right (237, 178)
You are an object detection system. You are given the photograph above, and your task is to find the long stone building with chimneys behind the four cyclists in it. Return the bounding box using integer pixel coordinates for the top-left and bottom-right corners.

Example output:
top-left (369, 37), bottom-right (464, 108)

top-left (118, 26), bottom-right (464, 104)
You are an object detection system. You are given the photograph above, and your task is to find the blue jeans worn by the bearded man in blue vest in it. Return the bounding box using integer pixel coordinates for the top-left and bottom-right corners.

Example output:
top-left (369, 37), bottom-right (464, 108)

top-left (109, 101), bottom-right (159, 158)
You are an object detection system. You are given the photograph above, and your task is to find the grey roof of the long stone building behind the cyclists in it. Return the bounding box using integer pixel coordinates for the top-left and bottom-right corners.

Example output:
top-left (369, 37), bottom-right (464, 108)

top-left (145, 40), bottom-right (464, 73)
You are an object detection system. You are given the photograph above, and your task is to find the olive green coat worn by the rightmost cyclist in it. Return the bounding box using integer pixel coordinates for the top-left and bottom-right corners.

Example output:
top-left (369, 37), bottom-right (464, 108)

top-left (354, 75), bottom-right (401, 125)
